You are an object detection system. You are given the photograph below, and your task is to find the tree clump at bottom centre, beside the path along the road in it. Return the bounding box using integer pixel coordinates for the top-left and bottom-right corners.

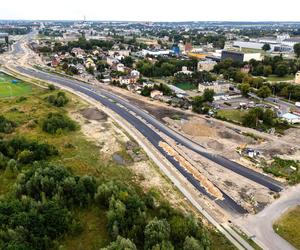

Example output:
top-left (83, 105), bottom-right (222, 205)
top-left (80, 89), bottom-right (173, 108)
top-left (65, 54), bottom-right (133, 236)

top-left (95, 182), bottom-right (210, 250)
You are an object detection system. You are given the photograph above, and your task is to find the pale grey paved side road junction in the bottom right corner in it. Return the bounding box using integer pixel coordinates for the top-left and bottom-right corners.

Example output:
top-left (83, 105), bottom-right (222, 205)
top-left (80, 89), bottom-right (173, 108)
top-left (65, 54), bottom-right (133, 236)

top-left (235, 184), bottom-right (300, 250)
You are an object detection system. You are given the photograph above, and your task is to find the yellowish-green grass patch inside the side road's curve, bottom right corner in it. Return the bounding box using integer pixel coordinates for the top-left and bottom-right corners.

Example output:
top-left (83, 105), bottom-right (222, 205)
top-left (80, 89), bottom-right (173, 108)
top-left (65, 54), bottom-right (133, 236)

top-left (273, 206), bottom-right (300, 249)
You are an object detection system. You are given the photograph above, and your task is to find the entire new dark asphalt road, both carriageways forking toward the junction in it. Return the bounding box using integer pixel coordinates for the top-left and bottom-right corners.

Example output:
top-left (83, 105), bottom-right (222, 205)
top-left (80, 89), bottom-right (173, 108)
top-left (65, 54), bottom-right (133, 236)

top-left (12, 66), bottom-right (282, 214)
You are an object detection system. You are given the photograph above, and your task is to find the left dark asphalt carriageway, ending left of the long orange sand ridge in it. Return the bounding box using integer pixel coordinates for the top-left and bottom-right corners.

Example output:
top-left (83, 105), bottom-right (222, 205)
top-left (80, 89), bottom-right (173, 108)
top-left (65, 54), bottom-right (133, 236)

top-left (12, 67), bottom-right (246, 214)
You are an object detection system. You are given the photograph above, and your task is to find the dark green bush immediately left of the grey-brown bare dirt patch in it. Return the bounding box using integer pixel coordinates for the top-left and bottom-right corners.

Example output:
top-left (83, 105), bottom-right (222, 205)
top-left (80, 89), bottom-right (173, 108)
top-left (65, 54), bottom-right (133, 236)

top-left (42, 113), bottom-right (78, 134)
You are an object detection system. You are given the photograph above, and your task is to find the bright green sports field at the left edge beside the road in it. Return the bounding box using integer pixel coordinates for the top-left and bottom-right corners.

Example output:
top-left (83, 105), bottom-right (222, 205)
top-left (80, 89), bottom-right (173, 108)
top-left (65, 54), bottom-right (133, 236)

top-left (0, 72), bottom-right (31, 98)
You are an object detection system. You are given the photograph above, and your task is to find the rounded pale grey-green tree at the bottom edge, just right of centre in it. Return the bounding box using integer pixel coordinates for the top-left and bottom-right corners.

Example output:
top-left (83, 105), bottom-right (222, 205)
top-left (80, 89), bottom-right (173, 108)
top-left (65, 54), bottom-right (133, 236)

top-left (144, 218), bottom-right (170, 249)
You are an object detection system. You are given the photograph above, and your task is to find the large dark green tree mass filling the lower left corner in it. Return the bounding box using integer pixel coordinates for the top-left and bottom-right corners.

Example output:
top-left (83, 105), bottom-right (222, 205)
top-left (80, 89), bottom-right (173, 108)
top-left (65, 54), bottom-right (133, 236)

top-left (0, 162), bottom-right (96, 249)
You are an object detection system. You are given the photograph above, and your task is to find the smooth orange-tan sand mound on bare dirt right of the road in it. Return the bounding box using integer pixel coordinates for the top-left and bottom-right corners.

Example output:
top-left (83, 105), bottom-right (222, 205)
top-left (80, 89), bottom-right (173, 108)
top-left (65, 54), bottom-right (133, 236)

top-left (182, 121), bottom-right (216, 137)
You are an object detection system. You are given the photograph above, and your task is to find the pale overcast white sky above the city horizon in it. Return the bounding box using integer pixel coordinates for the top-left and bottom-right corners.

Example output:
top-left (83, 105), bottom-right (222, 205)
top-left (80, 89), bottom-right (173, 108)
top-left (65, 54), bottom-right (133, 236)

top-left (0, 0), bottom-right (300, 21)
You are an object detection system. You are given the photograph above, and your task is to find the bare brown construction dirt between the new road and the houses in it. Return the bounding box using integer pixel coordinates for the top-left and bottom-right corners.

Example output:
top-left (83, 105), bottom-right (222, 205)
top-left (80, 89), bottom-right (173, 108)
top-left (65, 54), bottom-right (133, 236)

top-left (103, 86), bottom-right (300, 161)
